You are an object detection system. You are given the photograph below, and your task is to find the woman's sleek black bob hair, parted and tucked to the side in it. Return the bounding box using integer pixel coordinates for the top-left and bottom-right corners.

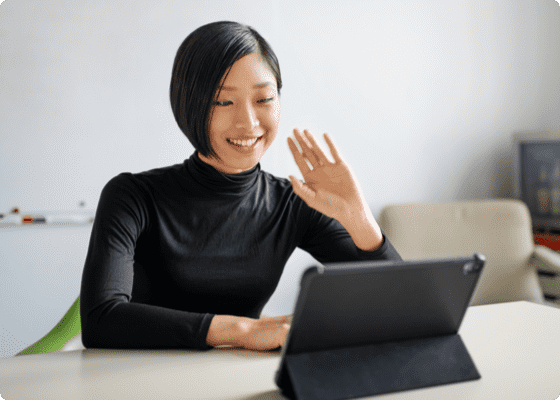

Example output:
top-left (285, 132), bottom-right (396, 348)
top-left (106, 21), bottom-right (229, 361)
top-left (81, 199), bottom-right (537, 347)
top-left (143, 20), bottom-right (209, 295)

top-left (169, 21), bottom-right (282, 157)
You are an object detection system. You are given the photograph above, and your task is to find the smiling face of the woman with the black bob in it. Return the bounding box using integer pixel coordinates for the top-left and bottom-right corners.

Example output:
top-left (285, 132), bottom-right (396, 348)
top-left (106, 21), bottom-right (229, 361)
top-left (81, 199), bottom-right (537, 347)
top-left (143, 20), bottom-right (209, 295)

top-left (199, 54), bottom-right (280, 174)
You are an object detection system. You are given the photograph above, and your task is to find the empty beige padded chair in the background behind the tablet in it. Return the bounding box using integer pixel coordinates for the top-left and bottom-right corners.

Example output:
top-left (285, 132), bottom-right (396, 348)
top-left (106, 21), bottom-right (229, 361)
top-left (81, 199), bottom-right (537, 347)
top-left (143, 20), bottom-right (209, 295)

top-left (378, 199), bottom-right (560, 305)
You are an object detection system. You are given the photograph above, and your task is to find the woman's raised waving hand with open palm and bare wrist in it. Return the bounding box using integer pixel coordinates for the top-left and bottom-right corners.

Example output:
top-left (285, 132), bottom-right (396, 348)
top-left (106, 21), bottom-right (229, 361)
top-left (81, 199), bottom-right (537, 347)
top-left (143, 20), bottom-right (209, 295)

top-left (288, 129), bottom-right (383, 250)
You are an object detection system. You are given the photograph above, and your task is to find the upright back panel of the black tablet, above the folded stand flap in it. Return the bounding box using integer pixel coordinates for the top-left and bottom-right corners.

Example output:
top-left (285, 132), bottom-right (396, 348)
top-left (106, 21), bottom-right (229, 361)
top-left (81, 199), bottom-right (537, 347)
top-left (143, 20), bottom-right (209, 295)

top-left (275, 254), bottom-right (486, 396)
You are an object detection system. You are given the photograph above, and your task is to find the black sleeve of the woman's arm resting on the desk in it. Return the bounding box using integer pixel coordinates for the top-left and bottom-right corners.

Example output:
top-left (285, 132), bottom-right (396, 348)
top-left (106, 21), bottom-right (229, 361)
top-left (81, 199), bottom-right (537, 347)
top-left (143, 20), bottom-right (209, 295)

top-left (80, 174), bottom-right (213, 349)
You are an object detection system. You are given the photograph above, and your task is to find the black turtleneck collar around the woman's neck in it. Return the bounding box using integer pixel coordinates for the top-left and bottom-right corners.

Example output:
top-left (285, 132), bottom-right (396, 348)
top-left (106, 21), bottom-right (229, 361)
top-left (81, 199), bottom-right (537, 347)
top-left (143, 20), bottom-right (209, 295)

top-left (184, 151), bottom-right (261, 194)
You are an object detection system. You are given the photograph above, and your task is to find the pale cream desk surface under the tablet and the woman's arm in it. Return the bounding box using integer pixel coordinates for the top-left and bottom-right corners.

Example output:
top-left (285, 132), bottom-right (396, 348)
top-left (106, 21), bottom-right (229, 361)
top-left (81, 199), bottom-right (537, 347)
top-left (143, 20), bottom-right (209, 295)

top-left (0, 302), bottom-right (560, 400)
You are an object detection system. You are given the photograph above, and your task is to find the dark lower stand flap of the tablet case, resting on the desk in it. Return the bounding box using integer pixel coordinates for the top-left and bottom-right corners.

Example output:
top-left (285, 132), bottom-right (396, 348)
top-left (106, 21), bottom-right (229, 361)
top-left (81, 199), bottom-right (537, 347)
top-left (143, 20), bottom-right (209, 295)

top-left (285, 334), bottom-right (480, 400)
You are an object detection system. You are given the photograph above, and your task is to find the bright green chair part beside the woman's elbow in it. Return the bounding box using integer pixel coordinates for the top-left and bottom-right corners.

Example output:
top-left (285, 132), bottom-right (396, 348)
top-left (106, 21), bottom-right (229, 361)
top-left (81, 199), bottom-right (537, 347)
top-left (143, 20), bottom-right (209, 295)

top-left (16, 296), bottom-right (82, 356)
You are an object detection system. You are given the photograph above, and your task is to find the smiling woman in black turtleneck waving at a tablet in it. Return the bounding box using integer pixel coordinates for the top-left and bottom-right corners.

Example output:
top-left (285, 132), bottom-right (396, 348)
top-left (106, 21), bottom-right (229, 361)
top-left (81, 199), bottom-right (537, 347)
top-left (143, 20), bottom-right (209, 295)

top-left (81, 22), bottom-right (400, 350)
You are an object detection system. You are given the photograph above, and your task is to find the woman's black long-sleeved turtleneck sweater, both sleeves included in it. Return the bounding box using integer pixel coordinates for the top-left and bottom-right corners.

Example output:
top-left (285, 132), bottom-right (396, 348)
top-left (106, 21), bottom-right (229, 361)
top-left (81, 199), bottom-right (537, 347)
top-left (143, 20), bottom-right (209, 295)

top-left (80, 153), bottom-right (401, 349)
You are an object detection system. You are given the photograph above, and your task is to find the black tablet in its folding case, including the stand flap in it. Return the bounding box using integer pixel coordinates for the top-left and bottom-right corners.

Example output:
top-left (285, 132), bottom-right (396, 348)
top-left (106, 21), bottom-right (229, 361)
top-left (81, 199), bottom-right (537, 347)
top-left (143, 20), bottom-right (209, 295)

top-left (276, 254), bottom-right (485, 400)
